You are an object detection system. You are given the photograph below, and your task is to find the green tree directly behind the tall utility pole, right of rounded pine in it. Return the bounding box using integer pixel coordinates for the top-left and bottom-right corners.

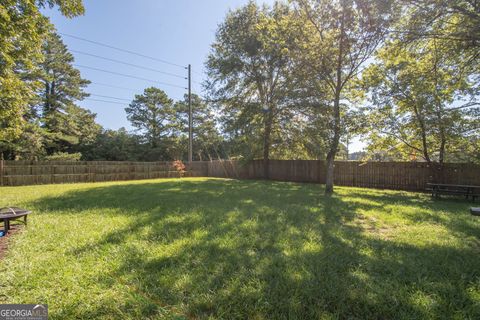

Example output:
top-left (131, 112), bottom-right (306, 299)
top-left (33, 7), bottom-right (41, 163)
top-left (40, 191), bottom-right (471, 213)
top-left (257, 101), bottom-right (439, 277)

top-left (174, 94), bottom-right (221, 161)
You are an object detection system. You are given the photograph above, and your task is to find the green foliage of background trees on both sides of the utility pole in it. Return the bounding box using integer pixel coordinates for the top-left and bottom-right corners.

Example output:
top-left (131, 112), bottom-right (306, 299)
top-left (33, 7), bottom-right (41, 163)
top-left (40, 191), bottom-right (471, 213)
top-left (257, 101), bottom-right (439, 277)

top-left (124, 87), bottom-right (222, 161)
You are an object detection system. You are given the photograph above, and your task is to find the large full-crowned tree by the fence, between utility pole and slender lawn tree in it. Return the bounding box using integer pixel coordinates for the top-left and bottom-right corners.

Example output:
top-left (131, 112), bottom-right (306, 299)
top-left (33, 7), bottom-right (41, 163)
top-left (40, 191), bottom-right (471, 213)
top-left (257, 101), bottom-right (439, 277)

top-left (206, 2), bottom-right (293, 178)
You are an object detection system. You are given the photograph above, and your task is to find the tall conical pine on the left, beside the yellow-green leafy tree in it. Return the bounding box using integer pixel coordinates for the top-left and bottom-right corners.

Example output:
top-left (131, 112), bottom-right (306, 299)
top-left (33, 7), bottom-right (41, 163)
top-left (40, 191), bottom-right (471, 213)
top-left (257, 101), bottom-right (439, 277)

top-left (2, 29), bottom-right (100, 159)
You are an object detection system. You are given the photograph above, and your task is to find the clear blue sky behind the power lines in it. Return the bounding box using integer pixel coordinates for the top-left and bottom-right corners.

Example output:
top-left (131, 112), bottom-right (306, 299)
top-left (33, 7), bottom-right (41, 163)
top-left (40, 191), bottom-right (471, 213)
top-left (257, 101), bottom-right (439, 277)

top-left (45, 0), bottom-right (361, 151)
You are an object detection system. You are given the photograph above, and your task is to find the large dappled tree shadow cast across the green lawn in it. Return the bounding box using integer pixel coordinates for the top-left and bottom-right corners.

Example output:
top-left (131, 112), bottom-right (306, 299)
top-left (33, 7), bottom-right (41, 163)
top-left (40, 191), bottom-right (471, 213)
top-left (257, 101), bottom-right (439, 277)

top-left (32, 180), bottom-right (480, 319)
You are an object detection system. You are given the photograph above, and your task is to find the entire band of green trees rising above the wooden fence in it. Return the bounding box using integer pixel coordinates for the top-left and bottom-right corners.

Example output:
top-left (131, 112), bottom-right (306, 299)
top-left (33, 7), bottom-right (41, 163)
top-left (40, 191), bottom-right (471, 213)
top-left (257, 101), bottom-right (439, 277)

top-left (0, 0), bottom-right (480, 191)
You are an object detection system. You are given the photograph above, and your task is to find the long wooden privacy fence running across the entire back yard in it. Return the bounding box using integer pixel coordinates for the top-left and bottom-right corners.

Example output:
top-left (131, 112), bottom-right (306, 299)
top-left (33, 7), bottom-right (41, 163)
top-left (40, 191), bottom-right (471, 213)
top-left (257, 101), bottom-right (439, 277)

top-left (0, 160), bottom-right (480, 191)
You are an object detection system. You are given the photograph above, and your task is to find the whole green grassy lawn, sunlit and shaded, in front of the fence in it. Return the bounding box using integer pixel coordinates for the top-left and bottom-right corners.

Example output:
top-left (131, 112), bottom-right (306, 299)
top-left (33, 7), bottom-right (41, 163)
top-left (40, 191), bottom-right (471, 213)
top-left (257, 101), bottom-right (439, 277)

top-left (0, 178), bottom-right (480, 319)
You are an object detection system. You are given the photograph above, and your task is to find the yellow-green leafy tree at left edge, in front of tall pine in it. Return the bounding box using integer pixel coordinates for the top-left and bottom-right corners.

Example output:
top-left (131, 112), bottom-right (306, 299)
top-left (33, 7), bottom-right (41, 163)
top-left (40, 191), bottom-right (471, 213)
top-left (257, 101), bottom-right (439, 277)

top-left (0, 0), bottom-right (84, 148)
